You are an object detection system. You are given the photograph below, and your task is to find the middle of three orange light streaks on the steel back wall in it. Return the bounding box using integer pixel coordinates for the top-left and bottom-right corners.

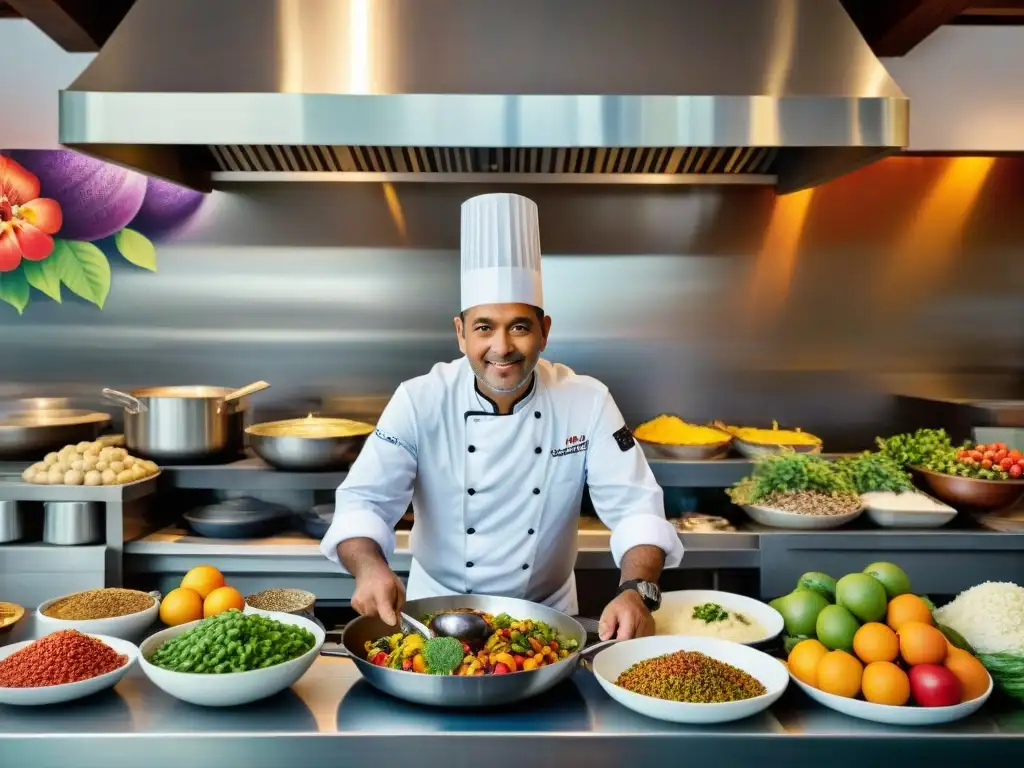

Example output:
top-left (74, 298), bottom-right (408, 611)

top-left (744, 188), bottom-right (814, 323)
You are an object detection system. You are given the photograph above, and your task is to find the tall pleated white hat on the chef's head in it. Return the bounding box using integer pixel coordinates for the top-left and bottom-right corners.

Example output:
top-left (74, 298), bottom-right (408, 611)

top-left (462, 194), bottom-right (544, 311)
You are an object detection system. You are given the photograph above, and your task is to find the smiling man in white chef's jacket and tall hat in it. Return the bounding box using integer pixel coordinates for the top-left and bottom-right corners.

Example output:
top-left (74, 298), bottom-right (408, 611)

top-left (321, 194), bottom-right (683, 639)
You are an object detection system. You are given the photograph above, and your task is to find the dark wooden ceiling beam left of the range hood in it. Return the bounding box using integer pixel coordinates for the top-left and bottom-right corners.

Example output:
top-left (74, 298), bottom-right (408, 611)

top-left (6, 0), bottom-right (135, 53)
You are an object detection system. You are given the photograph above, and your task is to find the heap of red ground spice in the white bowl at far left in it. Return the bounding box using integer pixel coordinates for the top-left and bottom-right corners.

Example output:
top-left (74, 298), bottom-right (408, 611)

top-left (0, 630), bottom-right (128, 688)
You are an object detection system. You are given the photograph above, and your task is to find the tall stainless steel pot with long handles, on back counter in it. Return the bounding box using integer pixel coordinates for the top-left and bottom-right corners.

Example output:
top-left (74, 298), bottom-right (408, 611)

top-left (103, 386), bottom-right (249, 464)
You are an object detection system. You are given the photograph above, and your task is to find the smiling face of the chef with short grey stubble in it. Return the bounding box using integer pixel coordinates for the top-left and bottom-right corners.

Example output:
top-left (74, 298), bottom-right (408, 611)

top-left (455, 304), bottom-right (551, 399)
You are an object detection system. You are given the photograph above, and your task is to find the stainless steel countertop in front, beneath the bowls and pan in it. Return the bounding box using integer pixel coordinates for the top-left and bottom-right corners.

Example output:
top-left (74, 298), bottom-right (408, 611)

top-left (0, 657), bottom-right (1024, 768)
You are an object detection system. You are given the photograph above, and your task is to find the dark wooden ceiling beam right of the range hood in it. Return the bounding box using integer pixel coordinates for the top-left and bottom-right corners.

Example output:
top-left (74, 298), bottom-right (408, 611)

top-left (843, 0), bottom-right (985, 56)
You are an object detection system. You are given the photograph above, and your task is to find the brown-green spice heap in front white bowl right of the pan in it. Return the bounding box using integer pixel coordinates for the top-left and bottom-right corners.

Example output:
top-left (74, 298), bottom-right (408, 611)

top-left (615, 650), bottom-right (767, 703)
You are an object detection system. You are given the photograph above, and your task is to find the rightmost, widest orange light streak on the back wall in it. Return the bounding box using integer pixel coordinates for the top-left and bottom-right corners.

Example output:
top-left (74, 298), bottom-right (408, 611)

top-left (878, 158), bottom-right (995, 298)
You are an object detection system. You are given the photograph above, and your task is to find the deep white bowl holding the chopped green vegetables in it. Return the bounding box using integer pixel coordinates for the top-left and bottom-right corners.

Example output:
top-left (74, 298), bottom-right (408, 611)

top-left (139, 613), bottom-right (326, 707)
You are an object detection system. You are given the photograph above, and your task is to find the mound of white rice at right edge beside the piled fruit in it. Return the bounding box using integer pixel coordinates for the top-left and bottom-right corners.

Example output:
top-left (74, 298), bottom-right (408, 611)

top-left (935, 582), bottom-right (1024, 654)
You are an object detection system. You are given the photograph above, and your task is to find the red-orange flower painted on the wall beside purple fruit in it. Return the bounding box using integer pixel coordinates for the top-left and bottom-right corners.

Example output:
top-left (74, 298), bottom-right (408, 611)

top-left (0, 155), bottom-right (62, 272)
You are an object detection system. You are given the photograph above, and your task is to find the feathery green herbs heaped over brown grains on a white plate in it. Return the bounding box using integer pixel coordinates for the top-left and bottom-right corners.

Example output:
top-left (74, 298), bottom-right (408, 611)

top-left (726, 453), bottom-right (856, 505)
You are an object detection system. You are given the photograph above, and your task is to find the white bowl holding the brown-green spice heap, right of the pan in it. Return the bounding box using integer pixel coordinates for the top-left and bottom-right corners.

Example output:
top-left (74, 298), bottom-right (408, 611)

top-left (593, 636), bottom-right (790, 724)
